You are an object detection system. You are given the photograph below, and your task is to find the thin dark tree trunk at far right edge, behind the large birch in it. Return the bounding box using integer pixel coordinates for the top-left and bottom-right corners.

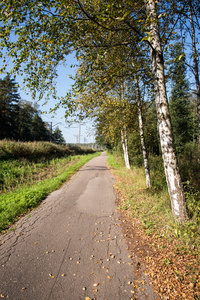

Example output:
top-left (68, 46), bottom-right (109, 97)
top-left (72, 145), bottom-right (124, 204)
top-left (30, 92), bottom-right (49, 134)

top-left (189, 1), bottom-right (200, 150)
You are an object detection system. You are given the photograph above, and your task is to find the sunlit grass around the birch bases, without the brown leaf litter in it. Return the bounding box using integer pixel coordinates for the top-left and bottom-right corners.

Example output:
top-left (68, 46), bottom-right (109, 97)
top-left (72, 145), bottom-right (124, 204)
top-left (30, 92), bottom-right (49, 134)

top-left (108, 154), bottom-right (200, 251)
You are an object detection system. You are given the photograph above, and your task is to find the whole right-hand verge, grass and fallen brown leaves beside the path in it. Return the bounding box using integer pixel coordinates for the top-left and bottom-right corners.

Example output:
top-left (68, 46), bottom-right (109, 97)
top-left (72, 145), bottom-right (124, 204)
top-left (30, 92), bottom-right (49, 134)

top-left (108, 154), bottom-right (200, 300)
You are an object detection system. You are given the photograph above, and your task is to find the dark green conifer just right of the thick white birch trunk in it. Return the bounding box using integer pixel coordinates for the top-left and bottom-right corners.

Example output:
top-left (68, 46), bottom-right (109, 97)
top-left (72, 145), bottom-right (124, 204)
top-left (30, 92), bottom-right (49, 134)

top-left (169, 42), bottom-right (193, 152)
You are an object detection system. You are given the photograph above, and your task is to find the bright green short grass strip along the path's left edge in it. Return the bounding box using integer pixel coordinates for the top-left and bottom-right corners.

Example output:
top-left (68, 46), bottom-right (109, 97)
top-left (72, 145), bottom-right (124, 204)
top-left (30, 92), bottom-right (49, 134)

top-left (0, 153), bottom-right (99, 231)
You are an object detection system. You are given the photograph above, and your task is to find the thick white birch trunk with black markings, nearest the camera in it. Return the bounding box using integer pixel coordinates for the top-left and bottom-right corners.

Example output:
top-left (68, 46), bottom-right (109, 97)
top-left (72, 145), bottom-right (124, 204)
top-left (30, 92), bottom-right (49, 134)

top-left (146, 0), bottom-right (186, 223)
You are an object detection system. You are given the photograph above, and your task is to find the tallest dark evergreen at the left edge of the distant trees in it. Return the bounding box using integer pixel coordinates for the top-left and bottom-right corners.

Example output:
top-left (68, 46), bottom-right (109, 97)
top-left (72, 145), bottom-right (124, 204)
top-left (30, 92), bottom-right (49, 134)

top-left (0, 75), bottom-right (20, 139)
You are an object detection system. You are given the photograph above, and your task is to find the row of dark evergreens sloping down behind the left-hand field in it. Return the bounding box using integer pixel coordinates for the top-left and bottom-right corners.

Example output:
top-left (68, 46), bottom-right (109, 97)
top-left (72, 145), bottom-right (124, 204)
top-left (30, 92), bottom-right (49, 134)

top-left (0, 75), bottom-right (65, 144)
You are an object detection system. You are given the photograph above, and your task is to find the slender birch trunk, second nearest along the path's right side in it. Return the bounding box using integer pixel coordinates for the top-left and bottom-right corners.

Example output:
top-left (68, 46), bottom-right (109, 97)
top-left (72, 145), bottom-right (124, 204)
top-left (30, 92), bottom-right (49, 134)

top-left (135, 78), bottom-right (151, 188)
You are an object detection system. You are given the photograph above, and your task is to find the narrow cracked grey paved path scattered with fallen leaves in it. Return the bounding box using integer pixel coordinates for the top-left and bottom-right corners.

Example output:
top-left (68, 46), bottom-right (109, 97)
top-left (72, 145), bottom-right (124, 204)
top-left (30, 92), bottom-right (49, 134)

top-left (0, 153), bottom-right (157, 300)
